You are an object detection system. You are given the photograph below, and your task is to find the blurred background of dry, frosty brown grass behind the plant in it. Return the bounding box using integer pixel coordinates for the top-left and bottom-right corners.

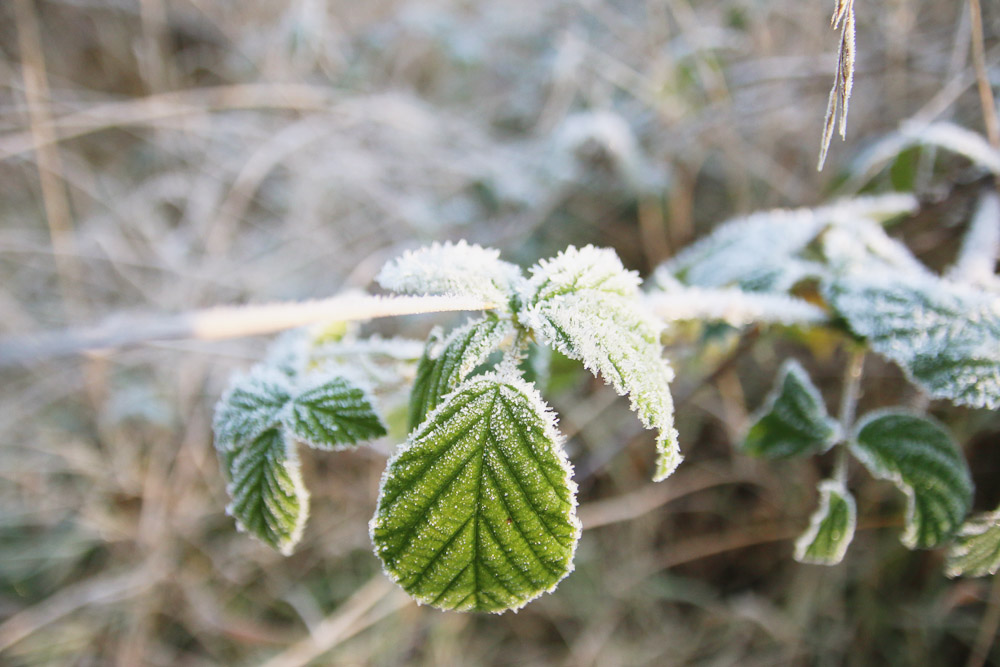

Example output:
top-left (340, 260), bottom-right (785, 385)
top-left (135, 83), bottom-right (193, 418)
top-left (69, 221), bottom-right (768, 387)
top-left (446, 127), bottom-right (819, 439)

top-left (0, 0), bottom-right (1000, 666)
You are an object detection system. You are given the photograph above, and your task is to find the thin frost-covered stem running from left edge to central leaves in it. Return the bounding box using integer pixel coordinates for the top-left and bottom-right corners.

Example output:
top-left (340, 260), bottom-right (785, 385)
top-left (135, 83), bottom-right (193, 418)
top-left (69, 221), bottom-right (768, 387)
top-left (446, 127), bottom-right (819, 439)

top-left (0, 294), bottom-right (495, 368)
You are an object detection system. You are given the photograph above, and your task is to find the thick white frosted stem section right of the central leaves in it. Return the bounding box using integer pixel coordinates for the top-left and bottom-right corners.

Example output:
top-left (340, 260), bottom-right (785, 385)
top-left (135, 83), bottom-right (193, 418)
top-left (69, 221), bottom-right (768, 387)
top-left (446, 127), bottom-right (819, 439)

top-left (646, 287), bottom-right (829, 327)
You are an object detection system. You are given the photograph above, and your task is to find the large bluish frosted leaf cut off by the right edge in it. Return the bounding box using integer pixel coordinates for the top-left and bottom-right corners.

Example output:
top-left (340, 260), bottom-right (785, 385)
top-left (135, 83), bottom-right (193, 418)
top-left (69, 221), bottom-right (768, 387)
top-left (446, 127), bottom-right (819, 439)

top-left (825, 271), bottom-right (1000, 409)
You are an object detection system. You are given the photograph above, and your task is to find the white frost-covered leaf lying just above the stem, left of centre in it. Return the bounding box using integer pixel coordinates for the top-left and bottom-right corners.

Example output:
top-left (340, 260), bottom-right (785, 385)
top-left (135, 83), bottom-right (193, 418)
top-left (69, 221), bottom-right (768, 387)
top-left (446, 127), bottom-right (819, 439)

top-left (376, 241), bottom-right (524, 309)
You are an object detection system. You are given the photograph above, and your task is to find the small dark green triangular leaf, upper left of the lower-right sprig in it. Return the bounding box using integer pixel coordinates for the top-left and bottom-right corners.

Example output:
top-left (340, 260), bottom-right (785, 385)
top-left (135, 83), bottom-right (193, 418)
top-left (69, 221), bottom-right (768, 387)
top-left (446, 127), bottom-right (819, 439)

top-left (743, 360), bottom-right (841, 459)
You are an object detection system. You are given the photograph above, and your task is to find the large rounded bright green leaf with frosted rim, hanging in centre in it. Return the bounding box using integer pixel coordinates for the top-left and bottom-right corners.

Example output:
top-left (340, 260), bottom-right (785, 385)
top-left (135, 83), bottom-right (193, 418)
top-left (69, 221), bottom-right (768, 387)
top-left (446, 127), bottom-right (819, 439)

top-left (371, 373), bottom-right (580, 612)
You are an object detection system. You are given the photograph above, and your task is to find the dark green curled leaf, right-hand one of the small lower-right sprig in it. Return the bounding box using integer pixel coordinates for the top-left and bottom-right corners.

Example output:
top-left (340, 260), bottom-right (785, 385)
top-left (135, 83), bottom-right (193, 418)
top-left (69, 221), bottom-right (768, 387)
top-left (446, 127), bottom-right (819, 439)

top-left (848, 411), bottom-right (972, 549)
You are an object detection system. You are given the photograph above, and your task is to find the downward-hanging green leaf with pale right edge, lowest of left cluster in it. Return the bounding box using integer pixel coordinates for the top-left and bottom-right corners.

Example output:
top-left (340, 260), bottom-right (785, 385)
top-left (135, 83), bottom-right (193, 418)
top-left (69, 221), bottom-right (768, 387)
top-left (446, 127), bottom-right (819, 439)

top-left (225, 428), bottom-right (309, 556)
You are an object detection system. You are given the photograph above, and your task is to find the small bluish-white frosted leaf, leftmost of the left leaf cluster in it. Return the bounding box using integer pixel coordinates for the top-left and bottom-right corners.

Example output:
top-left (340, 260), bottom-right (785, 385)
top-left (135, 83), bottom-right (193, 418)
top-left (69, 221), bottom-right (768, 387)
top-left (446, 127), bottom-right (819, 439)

top-left (212, 366), bottom-right (293, 451)
